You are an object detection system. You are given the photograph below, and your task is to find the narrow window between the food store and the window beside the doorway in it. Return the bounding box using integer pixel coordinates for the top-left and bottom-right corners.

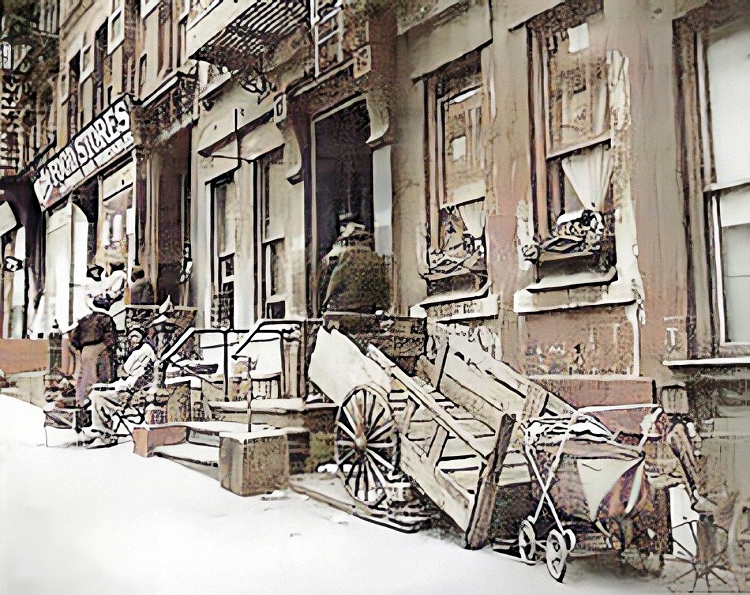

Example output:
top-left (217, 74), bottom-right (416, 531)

top-left (211, 177), bottom-right (237, 328)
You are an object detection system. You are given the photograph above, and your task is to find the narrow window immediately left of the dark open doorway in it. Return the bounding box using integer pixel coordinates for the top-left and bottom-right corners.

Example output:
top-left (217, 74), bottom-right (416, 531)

top-left (255, 149), bottom-right (286, 318)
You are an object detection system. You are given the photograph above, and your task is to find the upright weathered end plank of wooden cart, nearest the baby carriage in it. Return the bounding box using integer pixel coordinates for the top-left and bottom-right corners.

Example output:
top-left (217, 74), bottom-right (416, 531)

top-left (464, 415), bottom-right (516, 549)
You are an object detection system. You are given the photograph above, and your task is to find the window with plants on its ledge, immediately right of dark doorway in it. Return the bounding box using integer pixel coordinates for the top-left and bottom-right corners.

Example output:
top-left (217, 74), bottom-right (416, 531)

top-left (427, 54), bottom-right (487, 292)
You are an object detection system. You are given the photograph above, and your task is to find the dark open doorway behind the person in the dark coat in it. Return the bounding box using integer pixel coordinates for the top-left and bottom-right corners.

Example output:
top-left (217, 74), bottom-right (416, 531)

top-left (310, 100), bottom-right (374, 315)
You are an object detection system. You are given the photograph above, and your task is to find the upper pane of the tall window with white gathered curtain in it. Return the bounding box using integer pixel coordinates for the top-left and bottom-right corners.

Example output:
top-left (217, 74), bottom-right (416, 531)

top-left (546, 33), bottom-right (609, 151)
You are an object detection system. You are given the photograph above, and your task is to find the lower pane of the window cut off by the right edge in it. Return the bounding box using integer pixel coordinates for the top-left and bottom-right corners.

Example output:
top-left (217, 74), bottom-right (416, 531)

top-left (719, 188), bottom-right (750, 343)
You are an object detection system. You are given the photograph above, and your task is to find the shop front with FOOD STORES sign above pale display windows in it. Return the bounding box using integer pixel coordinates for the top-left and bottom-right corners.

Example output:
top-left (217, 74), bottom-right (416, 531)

top-left (34, 96), bottom-right (136, 334)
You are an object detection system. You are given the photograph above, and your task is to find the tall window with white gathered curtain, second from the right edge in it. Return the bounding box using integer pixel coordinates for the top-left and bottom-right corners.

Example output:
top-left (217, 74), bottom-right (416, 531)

top-left (527, 0), bottom-right (614, 277)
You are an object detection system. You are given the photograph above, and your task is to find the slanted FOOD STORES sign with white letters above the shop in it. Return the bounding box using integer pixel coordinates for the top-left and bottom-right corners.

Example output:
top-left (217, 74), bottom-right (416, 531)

top-left (34, 97), bottom-right (134, 208)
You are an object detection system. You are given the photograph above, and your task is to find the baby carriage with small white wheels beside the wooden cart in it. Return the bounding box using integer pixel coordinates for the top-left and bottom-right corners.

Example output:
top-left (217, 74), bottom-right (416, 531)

top-left (518, 405), bottom-right (661, 582)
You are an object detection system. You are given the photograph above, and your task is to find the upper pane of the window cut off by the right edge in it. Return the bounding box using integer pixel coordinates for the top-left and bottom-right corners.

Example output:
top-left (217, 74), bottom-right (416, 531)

top-left (707, 20), bottom-right (750, 184)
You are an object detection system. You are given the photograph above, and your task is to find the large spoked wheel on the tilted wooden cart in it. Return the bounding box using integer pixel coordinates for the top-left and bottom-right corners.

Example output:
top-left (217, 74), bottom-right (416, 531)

top-left (334, 387), bottom-right (398, 506)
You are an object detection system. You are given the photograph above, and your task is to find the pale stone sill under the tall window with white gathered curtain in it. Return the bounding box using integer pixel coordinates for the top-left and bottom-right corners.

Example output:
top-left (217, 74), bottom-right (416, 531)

top-left (513, 273), bottom-right (635, 314)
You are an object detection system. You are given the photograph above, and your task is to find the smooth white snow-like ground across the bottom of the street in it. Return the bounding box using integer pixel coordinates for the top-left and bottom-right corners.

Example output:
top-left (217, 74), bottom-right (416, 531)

top-left (0, 396), bottom-right (662, 595)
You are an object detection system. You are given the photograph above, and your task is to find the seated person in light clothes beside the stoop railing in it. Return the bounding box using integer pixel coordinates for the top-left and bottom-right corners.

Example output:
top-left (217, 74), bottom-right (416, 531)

top-left (89, 329), bottom-right (156, 443)
